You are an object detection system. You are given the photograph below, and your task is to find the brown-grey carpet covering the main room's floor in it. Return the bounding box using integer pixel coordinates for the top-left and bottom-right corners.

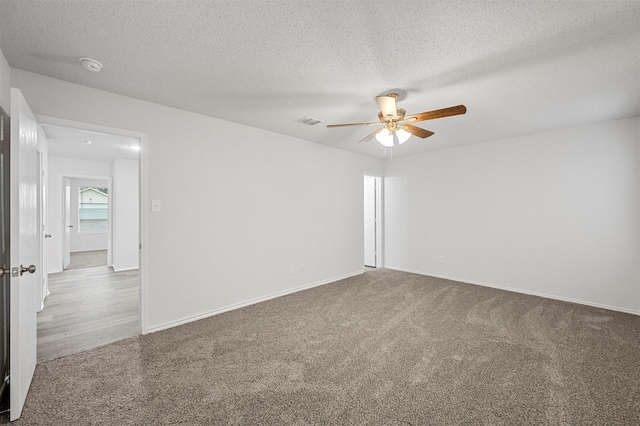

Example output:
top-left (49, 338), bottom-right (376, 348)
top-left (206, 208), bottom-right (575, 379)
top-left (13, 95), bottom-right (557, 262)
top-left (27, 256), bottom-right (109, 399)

top-left (6, 269), bottom-right (640, 425)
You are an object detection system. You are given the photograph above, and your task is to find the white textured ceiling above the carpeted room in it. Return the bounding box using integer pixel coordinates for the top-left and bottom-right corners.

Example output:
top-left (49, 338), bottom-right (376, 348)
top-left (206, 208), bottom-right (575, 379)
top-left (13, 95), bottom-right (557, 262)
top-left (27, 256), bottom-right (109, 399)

top-left (0, 0), bottom-right (640, 157)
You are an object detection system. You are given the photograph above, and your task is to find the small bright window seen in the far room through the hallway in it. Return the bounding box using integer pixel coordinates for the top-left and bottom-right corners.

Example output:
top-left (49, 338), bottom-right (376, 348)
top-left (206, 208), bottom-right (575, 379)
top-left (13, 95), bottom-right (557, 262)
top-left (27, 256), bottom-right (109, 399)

top-left (78, 186), bottom-right (109, 232)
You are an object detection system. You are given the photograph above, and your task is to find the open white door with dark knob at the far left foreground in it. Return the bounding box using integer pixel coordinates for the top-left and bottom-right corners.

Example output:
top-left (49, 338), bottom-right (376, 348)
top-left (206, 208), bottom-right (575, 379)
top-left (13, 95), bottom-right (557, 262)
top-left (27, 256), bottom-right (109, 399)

top-left (9, 89), bottom-right (41, 420)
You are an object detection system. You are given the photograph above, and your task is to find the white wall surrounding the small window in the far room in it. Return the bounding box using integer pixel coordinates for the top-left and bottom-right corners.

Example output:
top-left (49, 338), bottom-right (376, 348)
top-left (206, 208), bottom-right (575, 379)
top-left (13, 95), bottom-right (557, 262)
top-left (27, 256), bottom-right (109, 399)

top-left (67, 177), bottom-right (109, 253)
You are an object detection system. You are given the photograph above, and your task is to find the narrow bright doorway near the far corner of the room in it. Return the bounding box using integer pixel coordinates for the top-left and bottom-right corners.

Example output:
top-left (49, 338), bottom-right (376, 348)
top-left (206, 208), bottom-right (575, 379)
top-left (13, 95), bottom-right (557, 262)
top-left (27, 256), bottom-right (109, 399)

top-left (364, 175), bottom-right (382, 268)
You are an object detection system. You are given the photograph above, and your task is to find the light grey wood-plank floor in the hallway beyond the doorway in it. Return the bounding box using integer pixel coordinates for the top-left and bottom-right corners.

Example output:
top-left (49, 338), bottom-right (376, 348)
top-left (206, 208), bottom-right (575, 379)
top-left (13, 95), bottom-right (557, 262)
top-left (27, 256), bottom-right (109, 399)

top-left (38, 266), bottom-right (140, 362)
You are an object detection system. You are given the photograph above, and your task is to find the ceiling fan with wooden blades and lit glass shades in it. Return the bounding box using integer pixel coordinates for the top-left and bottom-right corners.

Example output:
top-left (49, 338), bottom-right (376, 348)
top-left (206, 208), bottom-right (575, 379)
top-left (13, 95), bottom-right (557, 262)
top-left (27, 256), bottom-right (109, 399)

top-left (327, 93), bottom-right (467, 147)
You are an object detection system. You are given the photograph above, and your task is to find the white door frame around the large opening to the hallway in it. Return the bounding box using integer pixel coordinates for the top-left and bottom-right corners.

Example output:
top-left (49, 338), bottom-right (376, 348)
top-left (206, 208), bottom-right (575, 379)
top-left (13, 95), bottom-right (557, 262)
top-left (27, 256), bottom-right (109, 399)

top-left (35, 114), bottom-right (149, 334)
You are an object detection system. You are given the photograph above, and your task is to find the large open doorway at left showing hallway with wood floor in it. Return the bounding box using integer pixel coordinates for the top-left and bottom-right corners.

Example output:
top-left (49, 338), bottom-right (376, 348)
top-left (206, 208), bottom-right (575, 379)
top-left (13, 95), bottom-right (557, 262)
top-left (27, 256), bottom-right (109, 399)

top-left (38, 117), bottom-right (145, 362)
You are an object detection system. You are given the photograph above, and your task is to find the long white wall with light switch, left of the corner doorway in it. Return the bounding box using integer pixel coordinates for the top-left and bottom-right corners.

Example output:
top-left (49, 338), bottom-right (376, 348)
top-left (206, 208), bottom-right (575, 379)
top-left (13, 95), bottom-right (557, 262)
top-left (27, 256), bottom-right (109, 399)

top-left (11, 69), bottom-right (382, 329)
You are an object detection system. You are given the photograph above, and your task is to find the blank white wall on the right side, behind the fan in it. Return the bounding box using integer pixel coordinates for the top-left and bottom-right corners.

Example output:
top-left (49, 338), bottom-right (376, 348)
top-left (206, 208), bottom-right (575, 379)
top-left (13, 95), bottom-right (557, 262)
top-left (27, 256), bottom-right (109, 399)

top-left (385, 117), bottom-right (640, 313)
